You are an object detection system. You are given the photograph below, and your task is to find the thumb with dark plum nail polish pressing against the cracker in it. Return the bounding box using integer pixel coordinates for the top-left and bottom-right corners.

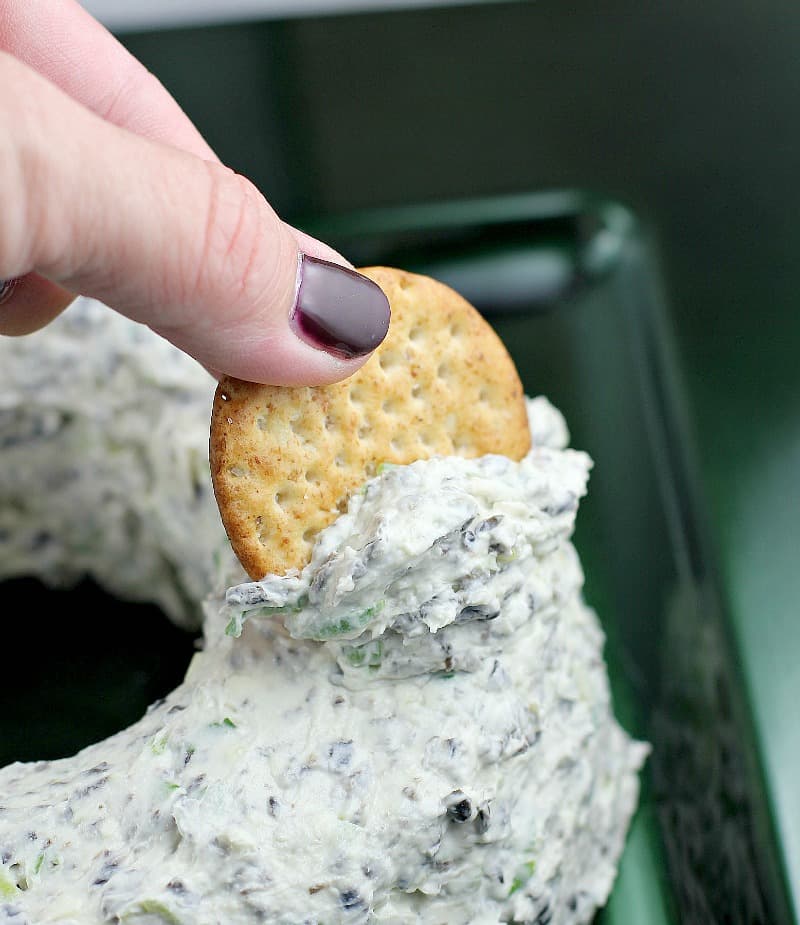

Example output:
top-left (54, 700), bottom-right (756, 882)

top-left (0, 54), bottom-right (389, 385)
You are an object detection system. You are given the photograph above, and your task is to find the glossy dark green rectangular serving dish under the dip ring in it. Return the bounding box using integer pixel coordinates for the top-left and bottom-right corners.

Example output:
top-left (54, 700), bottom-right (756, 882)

top-left (0, 192), bottom-right (792, 925)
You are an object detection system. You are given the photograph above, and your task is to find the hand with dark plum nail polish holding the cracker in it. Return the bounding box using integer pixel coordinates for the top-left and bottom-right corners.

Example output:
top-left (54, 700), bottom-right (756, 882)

top-left (0, 0), bottom-right (389, 385)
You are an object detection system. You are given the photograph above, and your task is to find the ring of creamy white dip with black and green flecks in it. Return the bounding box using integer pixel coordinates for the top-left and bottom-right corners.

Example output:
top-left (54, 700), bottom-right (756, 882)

top-left (0, 303), bottom-right (647, 925)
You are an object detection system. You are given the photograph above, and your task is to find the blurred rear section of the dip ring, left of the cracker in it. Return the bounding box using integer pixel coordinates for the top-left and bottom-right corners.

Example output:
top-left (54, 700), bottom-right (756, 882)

top-left (0, 299), bottom-right (230, 626)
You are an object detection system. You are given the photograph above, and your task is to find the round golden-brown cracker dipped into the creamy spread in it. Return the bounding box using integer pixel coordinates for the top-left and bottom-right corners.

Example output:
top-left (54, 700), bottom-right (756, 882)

top-left (210, 267), bottom-right (530, 579)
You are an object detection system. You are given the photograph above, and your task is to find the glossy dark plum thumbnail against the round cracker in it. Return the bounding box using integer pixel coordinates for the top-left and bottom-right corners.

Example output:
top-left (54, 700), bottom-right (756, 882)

top-left (291, 254), bottom-right (390, 359)
